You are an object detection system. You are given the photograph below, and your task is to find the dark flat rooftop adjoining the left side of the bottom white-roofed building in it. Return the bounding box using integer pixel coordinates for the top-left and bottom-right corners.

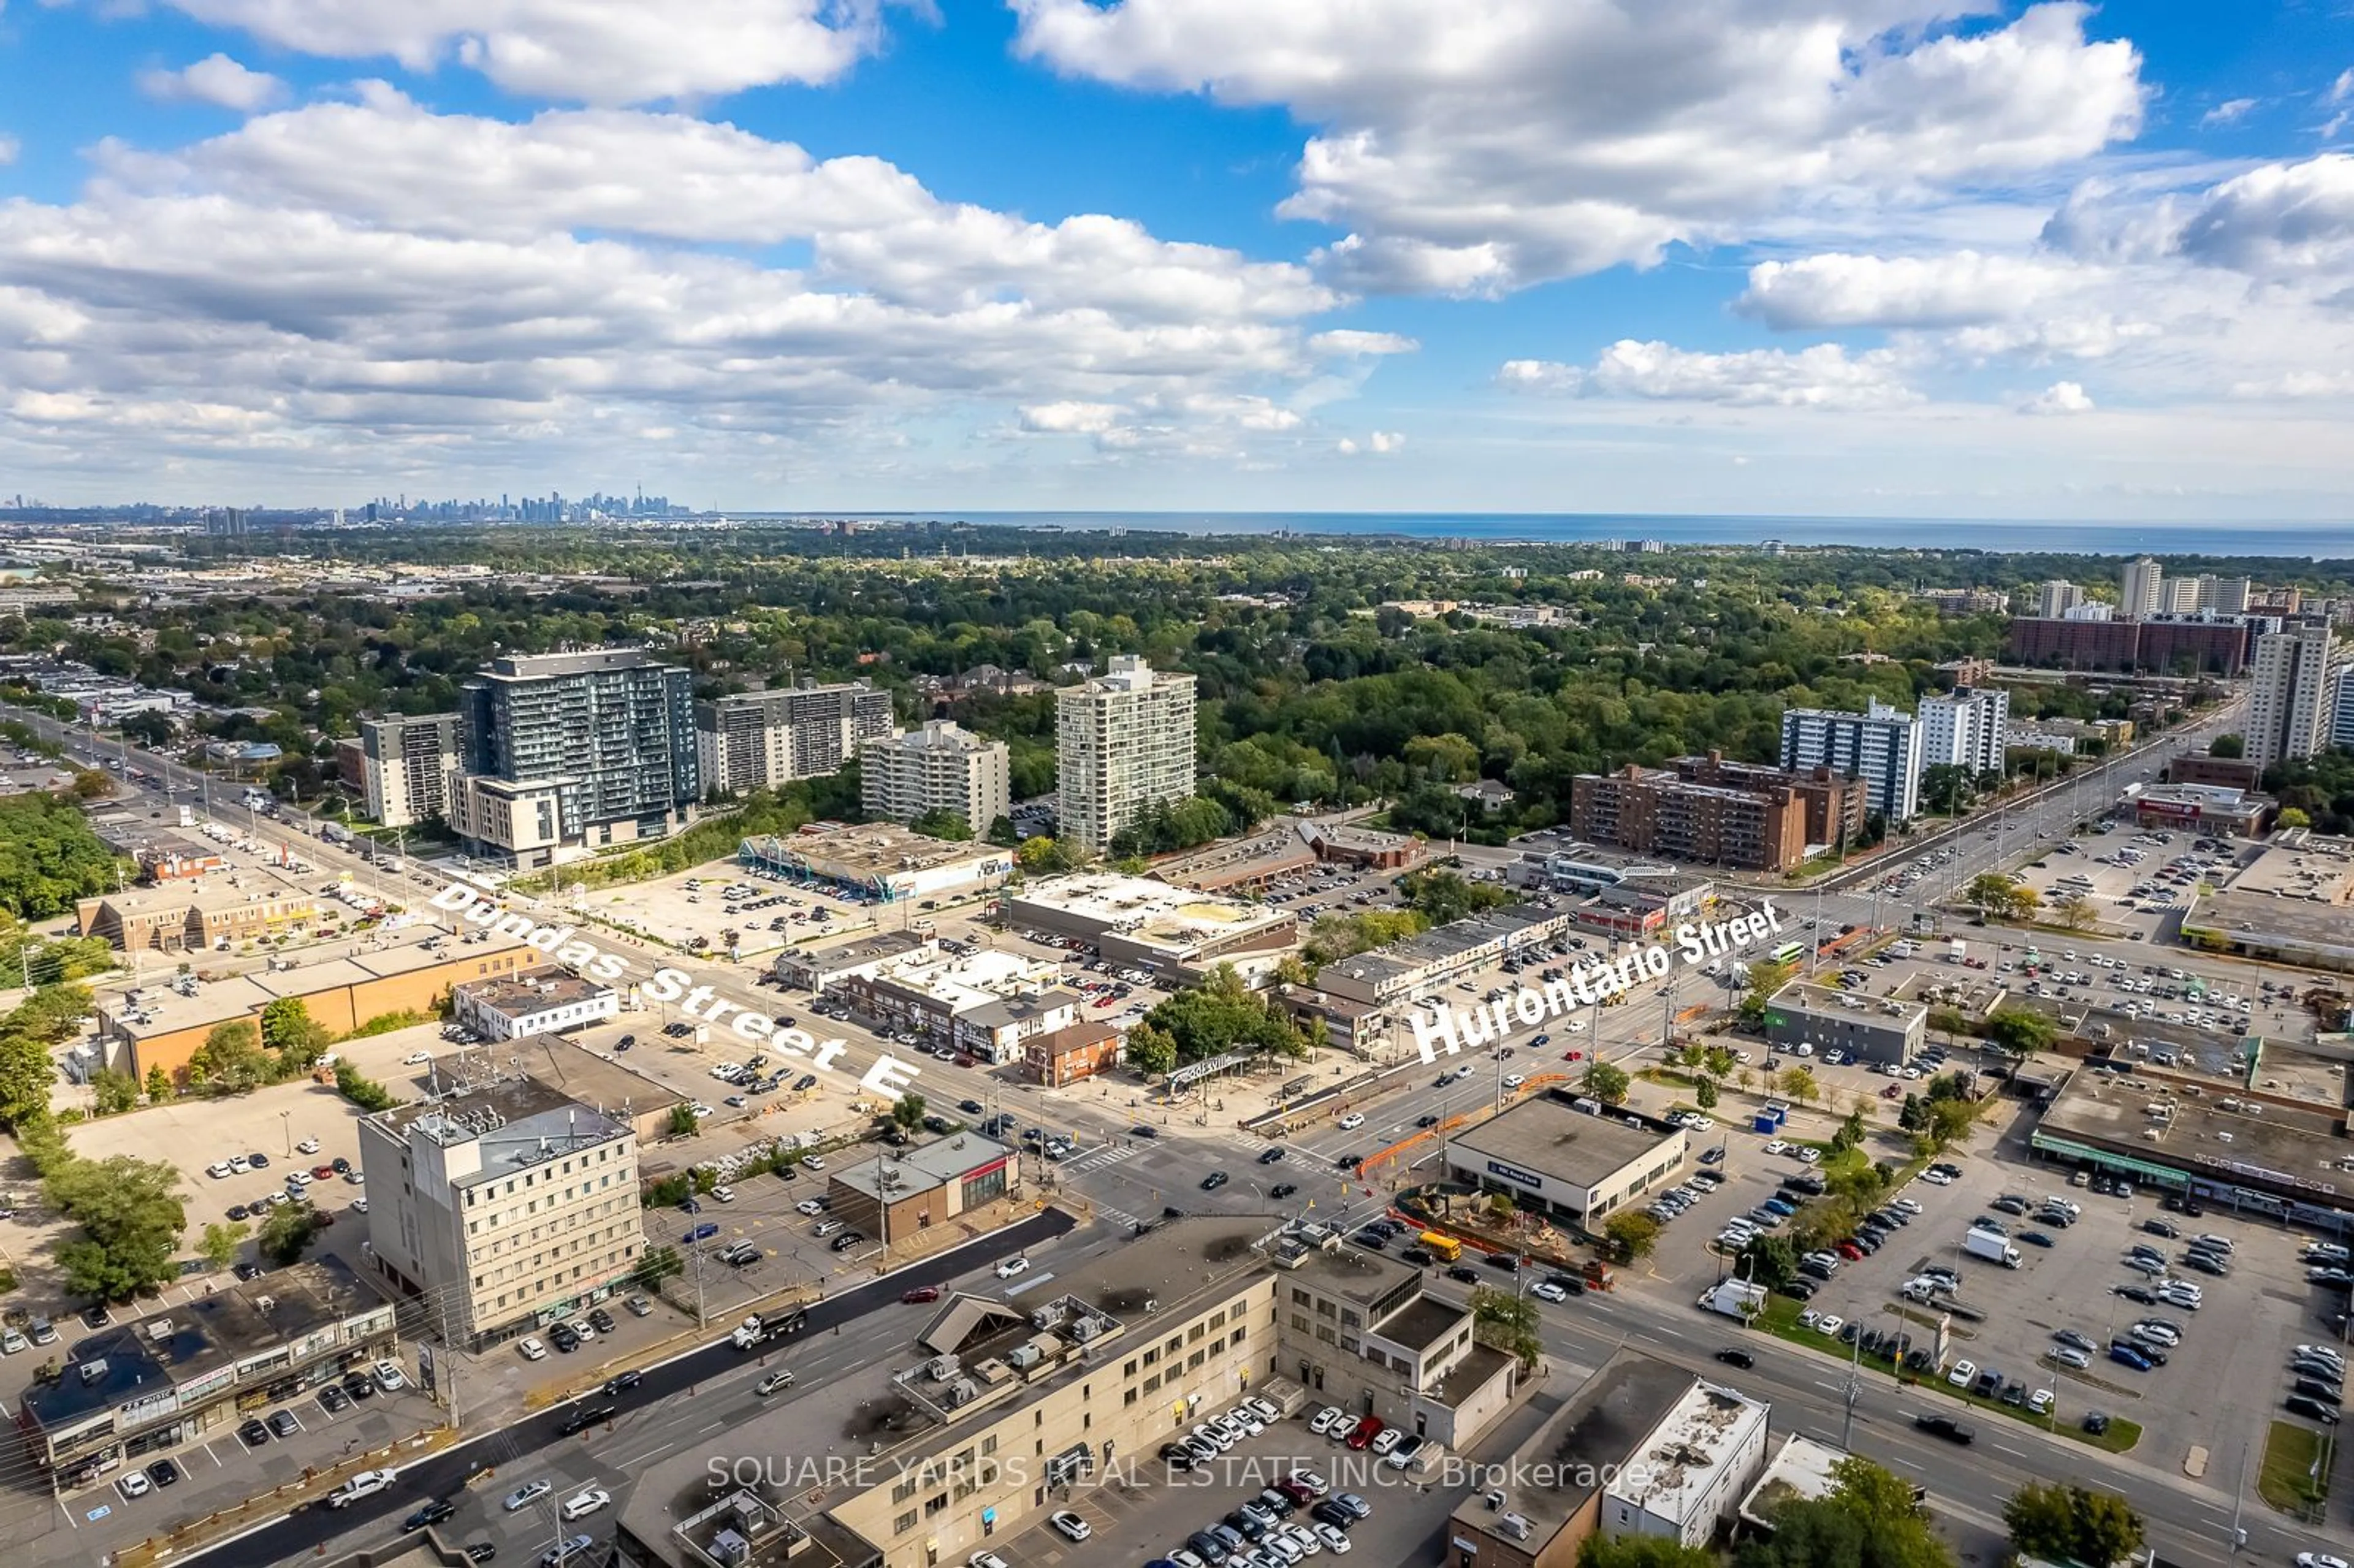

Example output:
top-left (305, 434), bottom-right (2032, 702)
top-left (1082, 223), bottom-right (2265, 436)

top-left (1455, 1352), bottom-right (1697, 1556)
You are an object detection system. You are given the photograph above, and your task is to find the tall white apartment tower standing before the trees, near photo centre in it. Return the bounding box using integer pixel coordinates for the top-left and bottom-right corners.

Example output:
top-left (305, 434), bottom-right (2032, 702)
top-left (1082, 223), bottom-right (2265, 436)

top-left (1054, 655), bottom-right (1196, 854)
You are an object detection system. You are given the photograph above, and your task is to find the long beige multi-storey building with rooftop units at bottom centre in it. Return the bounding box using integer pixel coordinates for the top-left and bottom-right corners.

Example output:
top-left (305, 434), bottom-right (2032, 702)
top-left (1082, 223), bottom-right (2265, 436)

top-left (617, 1215), bottom-right (1518, 1568)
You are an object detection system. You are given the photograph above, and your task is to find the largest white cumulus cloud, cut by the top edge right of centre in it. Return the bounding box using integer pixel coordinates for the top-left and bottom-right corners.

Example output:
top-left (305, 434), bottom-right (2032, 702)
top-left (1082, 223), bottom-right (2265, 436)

top-left (1012, 0), bottom-right (2144, 294)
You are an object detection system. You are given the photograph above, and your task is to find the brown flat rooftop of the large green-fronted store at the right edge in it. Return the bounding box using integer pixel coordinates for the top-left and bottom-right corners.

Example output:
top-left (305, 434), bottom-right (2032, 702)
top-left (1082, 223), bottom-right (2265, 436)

top-left (2038, 1048), bottom-right (2354, 1184)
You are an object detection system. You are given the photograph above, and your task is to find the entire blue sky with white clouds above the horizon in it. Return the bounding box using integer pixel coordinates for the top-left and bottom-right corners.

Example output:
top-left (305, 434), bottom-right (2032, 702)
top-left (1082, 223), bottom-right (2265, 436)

top-left (0, 0), bottom-right (2354, 518)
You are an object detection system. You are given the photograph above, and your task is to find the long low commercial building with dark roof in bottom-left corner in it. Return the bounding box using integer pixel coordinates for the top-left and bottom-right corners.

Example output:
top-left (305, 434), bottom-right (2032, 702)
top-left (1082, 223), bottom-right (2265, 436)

top-left (17, 1255), bottom-right (398, 1493)
